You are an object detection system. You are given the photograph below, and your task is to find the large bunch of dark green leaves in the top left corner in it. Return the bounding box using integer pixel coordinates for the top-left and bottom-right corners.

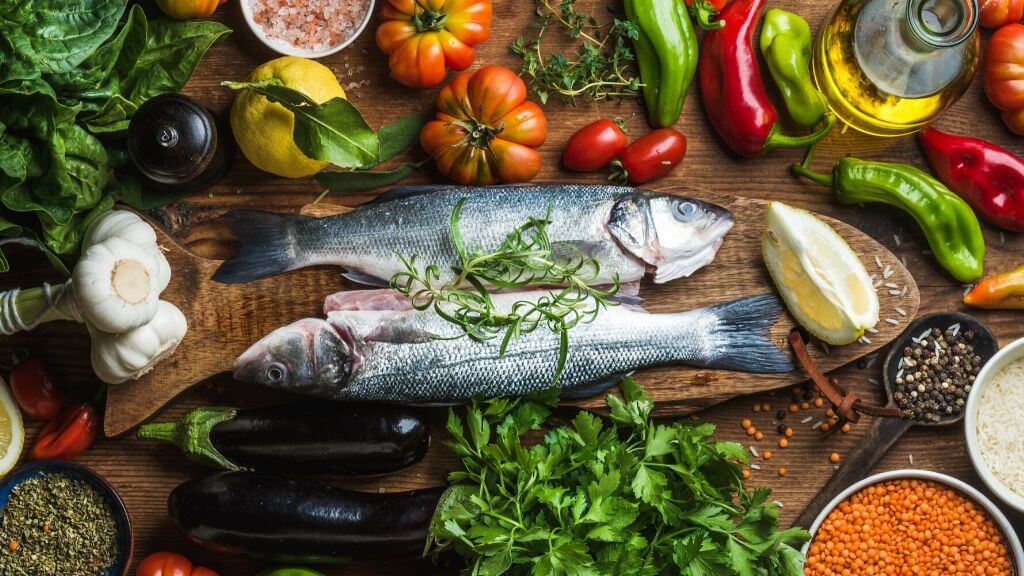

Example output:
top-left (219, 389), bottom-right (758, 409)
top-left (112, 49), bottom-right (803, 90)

top-left (0, 0), bottom-right (230, 271)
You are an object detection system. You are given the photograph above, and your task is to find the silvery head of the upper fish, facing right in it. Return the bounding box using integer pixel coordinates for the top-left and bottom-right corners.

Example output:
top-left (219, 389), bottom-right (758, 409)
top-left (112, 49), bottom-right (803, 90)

top-left (608, 194), bottom-right (735, 284)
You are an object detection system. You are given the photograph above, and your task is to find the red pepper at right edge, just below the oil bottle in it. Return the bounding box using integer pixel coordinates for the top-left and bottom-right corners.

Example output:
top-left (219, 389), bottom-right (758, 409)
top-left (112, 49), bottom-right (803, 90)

top-left (921, 128), bottom-right (1024, 232)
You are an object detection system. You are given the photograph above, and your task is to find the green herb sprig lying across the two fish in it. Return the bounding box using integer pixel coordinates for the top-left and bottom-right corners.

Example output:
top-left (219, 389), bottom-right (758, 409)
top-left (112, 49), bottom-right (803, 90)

top-left (391, 199), bottom-right (618, 382)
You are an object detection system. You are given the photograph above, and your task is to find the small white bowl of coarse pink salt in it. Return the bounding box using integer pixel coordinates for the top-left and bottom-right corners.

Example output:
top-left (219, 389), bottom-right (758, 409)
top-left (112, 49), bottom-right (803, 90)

top-left (241, 0), bottom-right (374, 58)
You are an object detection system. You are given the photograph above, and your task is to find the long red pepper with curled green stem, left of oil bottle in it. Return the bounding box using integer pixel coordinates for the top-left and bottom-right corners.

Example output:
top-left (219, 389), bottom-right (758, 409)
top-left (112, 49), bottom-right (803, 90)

top-left (697, 0), bottom-right (835, 156)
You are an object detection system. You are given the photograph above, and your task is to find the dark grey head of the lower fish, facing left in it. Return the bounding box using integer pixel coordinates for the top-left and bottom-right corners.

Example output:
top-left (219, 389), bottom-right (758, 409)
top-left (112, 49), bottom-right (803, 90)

top-left (233, 318), bottom-right (358, 396)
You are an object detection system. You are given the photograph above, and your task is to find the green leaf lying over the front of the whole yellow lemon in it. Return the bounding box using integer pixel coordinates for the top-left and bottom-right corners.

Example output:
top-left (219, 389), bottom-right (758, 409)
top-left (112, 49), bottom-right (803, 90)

top-left (224, 80), bottom-right (380, 168)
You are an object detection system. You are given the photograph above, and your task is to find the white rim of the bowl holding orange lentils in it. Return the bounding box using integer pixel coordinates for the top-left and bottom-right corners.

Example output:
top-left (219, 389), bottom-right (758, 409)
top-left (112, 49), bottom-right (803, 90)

top-left (802, 467), bottom-right (1024, 575)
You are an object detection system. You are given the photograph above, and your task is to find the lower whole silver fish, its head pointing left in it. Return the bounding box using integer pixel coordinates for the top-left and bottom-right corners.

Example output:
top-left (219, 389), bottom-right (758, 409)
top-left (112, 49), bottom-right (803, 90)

top-left (234, 290), bottom-right (793, 405)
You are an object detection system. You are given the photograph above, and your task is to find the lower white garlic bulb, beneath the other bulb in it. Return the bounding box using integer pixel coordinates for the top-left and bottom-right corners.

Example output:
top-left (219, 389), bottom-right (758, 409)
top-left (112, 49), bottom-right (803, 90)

top-left (90, 297), bottom-right (188, 384)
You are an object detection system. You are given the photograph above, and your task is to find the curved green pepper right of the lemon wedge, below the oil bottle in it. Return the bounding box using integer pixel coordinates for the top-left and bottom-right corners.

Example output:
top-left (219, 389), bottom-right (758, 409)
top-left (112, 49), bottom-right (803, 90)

top-left (793, 155), bottom-right (985, 282)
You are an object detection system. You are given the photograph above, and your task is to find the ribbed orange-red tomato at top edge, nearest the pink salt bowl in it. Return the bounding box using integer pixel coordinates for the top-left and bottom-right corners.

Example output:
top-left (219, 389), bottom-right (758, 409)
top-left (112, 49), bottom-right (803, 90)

top-left (377, 0), bottom-right (492, 88)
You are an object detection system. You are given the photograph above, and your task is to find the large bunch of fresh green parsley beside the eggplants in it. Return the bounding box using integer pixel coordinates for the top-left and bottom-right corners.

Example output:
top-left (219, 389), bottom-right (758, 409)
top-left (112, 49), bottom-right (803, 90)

top-left (428, 378), bottom-right (809, 576)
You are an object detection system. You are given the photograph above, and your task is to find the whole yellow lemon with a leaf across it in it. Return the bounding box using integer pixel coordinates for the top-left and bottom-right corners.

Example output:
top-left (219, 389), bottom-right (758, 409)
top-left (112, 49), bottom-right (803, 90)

top-left (231, 56), bottom-right (345, 178)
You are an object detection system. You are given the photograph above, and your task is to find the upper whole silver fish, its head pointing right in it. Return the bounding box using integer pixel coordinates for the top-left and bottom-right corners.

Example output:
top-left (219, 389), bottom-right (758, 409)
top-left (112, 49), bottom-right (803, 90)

top-left (214, 184), bottom-right (733, 286)
